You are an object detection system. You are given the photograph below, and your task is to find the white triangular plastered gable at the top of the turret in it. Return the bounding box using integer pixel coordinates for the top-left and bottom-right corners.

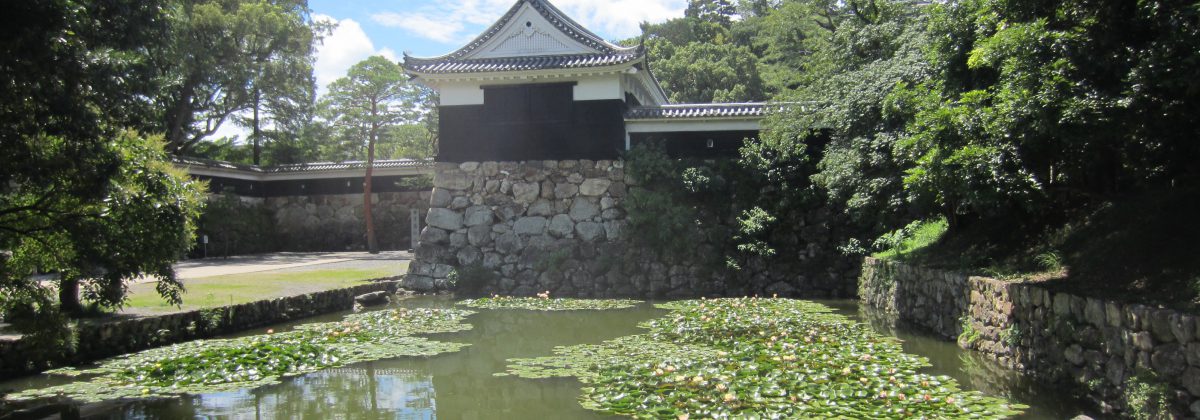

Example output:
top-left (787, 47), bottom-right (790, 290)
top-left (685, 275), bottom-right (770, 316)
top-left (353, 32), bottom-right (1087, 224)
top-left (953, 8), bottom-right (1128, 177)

top-left (463, 2), bottom-right (599, 59)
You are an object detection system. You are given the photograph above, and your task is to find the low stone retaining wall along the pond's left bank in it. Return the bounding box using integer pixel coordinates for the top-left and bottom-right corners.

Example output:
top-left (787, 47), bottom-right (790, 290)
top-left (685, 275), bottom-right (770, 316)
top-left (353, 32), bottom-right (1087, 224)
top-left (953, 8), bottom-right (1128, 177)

top-left (0, 281), bottom-right (400, 377)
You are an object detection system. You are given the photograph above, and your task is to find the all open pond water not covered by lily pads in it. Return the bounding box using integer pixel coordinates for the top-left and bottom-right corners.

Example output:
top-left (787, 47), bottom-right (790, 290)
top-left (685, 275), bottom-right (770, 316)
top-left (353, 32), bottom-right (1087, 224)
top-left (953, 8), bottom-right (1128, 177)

top-left (2, 298), bottom-right (1081, 420)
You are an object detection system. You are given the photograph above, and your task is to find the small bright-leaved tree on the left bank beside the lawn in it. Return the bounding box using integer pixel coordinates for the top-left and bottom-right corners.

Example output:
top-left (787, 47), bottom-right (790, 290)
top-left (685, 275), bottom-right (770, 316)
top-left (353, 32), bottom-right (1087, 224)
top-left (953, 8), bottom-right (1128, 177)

top-left (51, 131), bottom-right (203, 312)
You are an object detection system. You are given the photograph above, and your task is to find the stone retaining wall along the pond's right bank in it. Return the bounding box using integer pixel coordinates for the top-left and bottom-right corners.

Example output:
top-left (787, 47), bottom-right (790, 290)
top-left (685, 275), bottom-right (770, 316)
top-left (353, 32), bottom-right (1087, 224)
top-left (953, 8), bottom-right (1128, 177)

top-left (859, 258), bottom-right (1200, 418)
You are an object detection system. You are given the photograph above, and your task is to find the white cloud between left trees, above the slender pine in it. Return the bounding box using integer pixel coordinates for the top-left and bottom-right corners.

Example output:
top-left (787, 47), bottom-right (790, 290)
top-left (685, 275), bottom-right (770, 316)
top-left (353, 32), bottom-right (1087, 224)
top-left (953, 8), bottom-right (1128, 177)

top-left (313, 14), bottom-right (398, 94)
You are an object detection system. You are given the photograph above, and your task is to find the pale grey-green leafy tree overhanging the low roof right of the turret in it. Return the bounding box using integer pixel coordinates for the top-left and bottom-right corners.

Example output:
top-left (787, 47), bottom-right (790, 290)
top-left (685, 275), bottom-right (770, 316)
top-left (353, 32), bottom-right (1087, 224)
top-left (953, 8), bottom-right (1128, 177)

top-left (743, 2), bottom-right (931, 239)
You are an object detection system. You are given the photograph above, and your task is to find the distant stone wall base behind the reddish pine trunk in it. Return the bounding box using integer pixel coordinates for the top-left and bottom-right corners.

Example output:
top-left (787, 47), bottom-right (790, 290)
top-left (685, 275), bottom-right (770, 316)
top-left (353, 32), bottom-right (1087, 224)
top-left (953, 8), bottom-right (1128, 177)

top-left (264, 191), bottom-right (430, 251)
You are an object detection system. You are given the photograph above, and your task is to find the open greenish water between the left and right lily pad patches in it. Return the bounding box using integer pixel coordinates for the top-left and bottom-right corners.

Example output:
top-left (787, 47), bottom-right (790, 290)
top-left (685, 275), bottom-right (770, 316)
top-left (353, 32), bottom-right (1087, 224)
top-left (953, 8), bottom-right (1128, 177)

top-left (71, 299), bottom-right (665, 420)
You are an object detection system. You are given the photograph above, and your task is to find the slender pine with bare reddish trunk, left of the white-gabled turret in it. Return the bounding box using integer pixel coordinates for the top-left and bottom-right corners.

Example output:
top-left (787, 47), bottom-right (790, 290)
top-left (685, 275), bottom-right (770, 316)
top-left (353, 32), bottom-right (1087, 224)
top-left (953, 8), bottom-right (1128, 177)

top-left (320, 55), bottom-right (431, 252)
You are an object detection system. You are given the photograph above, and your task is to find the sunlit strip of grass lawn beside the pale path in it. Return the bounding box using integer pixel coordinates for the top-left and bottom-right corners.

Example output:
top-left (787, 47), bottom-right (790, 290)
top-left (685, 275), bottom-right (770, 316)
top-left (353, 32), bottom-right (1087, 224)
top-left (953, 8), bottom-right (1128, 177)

top-left (122, 268), bottom-right (396, 313)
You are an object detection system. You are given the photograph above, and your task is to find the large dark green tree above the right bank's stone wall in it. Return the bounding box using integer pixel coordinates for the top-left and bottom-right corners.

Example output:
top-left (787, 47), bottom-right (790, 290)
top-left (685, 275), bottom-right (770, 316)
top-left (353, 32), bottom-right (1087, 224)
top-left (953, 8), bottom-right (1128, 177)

top-left (902, 0), bottom-right (1200, 229)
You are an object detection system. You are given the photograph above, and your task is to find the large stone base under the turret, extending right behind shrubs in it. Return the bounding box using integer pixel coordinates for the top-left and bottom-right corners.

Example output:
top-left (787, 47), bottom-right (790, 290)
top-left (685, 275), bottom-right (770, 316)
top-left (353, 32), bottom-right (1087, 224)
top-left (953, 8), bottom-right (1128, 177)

top-left (406, 160), bottom-right (858, 299)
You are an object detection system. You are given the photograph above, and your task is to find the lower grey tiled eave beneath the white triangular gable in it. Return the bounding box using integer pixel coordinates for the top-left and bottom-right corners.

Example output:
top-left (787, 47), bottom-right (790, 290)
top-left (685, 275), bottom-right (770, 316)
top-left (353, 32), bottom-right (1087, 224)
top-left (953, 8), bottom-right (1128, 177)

top-left (404, 50), bottom-right (643, 73)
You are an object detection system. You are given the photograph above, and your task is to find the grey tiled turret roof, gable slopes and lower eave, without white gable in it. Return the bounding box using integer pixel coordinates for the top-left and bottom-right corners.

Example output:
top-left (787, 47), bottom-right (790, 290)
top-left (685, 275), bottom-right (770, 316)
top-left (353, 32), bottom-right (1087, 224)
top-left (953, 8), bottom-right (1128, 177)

top-left (403, 0), bottom-right (646, 73)
